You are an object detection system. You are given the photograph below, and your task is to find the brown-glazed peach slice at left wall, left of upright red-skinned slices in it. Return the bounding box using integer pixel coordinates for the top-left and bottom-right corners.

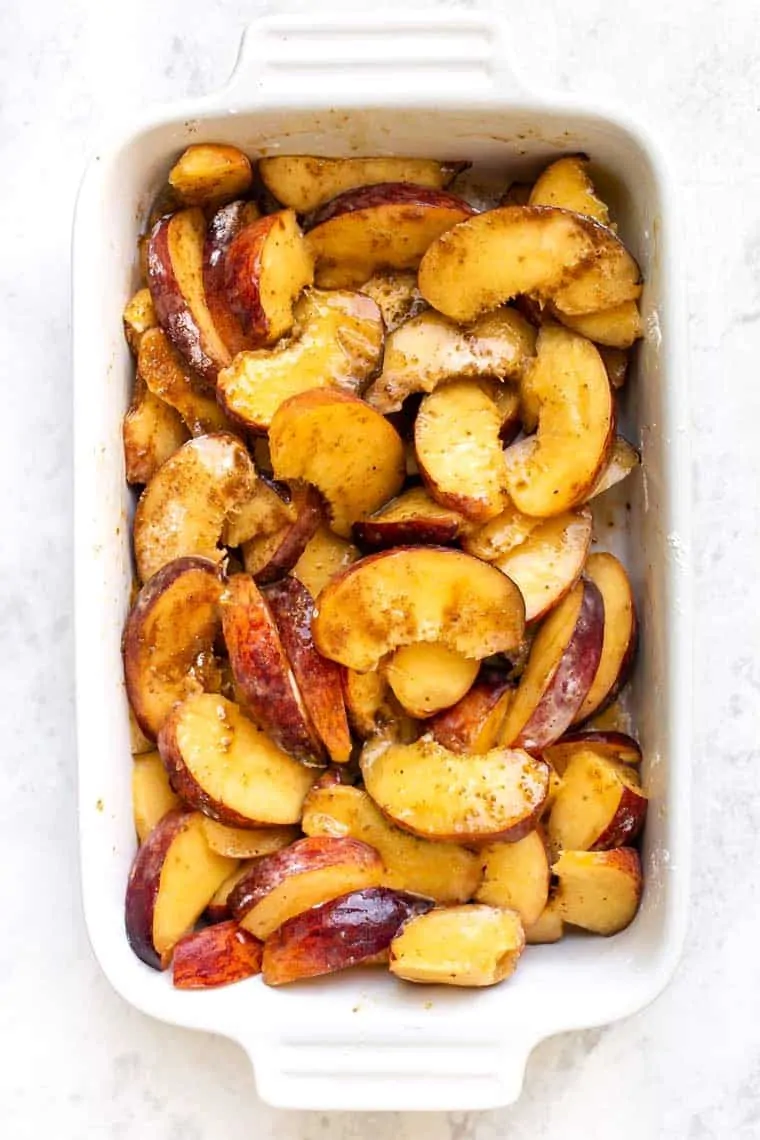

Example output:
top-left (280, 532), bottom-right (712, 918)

top-left (122, 557), bottom-right (222, 740)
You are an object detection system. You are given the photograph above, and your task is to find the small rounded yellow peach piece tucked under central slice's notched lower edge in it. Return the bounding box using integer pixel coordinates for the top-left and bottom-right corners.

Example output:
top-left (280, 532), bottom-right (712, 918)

top-left (385, 642), bottom-right (480, 719)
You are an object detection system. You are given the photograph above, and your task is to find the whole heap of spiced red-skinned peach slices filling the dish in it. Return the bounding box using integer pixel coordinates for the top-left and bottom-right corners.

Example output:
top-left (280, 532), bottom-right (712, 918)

top-left (123, 145), bottom-right (647, 988)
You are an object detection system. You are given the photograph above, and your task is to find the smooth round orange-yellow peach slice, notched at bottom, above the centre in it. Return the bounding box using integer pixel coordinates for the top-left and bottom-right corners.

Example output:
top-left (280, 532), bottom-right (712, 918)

top-left (269, 389), bottom-right (404, 538)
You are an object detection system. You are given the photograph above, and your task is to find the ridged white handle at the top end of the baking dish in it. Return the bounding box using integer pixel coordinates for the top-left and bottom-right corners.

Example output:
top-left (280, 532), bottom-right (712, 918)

top-left (228, 10), bottom-right (523, 107)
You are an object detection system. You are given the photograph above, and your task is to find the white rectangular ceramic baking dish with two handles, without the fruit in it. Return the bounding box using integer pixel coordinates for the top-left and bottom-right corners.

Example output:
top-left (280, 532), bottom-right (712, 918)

top-left (74, 14), bottom-right (690, 1109)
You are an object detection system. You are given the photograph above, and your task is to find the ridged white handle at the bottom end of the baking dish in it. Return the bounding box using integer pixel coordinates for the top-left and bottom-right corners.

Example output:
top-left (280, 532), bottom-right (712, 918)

top-left (244, 1034), bottom-right (536, 1112)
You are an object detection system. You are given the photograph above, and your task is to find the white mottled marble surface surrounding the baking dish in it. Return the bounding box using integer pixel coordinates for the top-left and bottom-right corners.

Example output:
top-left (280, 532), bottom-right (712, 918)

top-left (0, 0), bottom-right (760, 1140)
